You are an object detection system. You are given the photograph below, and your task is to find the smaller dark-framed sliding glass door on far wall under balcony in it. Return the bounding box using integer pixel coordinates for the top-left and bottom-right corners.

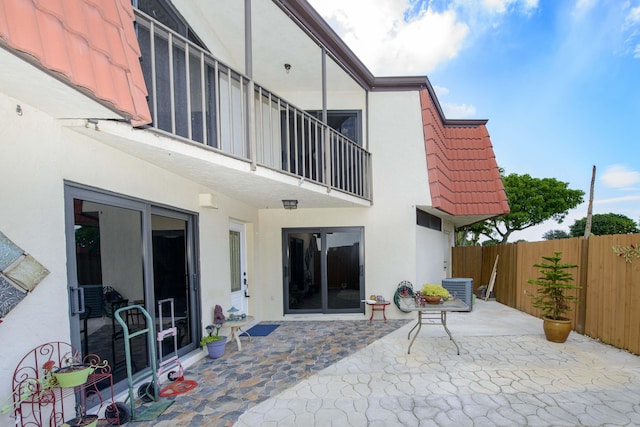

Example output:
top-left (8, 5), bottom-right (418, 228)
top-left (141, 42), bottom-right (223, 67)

top-left (283, 227), bottom-right (364, 313)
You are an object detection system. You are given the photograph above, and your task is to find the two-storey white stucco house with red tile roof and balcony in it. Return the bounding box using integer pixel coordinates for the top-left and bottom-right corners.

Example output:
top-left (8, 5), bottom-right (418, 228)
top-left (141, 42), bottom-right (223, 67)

top-left (0, 0), bottom-right (509, 412)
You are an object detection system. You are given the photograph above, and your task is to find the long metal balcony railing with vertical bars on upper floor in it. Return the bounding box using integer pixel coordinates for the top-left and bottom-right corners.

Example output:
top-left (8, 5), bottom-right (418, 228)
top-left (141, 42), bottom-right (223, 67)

top-left (136, 10), bottom-right (371, 200)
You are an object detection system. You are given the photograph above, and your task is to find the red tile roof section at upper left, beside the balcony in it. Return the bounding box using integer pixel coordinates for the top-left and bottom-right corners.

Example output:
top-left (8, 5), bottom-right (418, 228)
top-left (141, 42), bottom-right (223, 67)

top-left (0, 0), bottom-right (151, 126)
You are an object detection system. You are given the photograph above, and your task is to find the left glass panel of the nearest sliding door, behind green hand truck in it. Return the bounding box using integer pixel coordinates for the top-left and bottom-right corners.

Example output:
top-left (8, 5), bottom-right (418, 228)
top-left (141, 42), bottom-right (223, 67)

top-left (73, 199), bottom-right (149, 382)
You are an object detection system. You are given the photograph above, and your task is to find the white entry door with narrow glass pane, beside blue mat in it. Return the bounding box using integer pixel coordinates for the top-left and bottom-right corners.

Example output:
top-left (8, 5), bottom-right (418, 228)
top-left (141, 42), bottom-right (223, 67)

top-left (229, 222), bottom-right (249, 314)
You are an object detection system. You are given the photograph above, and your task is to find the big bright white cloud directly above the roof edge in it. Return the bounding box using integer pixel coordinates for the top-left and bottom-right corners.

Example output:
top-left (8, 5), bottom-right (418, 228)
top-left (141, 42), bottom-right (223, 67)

top-left (309, 0), bottom-right (539, 76)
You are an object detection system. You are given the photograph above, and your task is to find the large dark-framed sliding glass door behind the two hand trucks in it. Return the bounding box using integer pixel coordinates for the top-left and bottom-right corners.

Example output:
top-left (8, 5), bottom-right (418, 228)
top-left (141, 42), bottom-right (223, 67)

top-left (65, 185), bottom-right (199, 392)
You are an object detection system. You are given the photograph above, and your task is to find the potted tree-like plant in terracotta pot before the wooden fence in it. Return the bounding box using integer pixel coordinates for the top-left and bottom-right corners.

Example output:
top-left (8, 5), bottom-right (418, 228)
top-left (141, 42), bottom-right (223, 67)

top-left (527, 252), bottom-right (580, 343)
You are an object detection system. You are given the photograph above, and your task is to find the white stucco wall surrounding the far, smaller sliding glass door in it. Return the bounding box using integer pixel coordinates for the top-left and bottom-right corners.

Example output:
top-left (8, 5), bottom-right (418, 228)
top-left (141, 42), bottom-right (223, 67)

top-left (250, 93), bottom-right (448, 319)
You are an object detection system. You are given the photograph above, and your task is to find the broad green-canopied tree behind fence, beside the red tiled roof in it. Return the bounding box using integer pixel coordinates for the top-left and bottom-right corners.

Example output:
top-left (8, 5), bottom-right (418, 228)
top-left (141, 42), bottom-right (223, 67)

top-left (470, 173), bottom-right (584, 243)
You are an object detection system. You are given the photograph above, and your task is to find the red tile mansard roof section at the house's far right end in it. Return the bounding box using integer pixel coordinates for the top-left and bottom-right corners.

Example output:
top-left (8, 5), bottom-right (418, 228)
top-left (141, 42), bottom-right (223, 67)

top-left (420, 89), bottom-right (509, 216)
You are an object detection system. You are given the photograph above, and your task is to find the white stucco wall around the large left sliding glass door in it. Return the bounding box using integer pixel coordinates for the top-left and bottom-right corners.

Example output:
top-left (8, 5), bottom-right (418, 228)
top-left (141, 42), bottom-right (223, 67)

top-left (0, 94), bottom-right (257, 426)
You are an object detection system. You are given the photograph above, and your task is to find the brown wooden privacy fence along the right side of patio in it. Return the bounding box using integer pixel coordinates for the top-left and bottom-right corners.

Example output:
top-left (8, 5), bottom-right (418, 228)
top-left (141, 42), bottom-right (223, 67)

top-left (452, 234), bottom-right (640, 354)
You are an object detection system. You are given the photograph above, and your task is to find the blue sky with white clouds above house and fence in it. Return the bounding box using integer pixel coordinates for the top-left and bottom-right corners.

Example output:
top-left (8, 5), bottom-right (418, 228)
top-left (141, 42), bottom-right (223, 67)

top-left (308, 0), bottom-right (640, 242)
